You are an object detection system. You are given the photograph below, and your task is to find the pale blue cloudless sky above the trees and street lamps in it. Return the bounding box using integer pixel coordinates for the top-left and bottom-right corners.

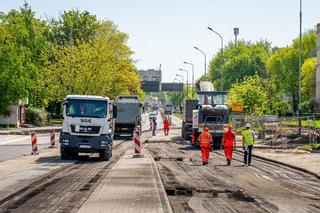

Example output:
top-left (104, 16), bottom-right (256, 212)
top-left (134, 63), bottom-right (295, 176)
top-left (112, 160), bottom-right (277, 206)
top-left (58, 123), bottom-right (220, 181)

top-left (0, 0), bottom-right (320, 82)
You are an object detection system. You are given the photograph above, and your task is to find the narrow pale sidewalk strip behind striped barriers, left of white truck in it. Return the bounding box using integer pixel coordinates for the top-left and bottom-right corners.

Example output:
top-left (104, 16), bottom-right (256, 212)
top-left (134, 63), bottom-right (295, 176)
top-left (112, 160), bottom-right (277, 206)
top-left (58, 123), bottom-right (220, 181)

top-left (0, 126), bottom-right (62, 135)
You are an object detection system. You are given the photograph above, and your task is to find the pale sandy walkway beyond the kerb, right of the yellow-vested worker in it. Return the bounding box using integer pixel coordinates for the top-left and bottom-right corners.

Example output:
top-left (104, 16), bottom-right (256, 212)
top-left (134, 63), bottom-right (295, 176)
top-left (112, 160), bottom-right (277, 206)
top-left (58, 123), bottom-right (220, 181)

top-left (252, 149), bottom-right (320, 176)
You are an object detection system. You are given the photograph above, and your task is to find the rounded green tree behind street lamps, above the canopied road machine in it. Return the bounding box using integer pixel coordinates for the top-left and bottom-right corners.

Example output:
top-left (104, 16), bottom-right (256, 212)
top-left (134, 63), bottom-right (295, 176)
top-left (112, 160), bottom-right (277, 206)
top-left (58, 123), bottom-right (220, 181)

top-left (209, 41), bottom-right (271, 90)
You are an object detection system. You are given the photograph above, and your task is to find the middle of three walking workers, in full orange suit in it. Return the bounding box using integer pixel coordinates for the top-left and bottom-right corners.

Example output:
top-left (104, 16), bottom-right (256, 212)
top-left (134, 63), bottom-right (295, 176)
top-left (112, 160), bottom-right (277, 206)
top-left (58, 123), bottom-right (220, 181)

top-left (222, 125), bottom-right (236, 166)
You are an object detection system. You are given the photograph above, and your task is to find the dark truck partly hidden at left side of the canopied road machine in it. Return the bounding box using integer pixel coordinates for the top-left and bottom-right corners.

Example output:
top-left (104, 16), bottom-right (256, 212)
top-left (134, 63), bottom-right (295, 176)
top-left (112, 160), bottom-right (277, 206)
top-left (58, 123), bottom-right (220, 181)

top-left (181, 99), bottom-right (199, 140)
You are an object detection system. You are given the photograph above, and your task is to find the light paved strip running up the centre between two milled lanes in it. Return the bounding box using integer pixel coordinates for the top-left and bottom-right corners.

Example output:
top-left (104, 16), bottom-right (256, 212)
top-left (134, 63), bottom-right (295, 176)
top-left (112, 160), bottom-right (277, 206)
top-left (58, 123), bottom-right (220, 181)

top-left (78, 149), bottom-right (172, 213)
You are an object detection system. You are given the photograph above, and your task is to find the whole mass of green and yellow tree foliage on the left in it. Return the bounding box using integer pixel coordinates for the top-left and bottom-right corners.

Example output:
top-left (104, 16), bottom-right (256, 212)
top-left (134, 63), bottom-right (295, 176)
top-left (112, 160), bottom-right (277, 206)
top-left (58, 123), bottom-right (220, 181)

top-left (0, 3), bottom-right (143, 113)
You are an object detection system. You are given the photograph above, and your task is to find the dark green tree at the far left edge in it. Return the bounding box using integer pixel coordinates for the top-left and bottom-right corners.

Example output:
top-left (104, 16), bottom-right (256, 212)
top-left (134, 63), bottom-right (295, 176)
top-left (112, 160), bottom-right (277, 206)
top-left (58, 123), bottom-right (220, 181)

top-left (0, 3), bottom-right (48, 112)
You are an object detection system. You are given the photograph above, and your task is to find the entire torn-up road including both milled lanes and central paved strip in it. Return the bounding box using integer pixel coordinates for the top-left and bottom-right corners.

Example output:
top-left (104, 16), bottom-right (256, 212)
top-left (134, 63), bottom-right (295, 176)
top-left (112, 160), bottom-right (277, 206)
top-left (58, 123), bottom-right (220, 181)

top-left (0, 115), bottom-right (320, 212)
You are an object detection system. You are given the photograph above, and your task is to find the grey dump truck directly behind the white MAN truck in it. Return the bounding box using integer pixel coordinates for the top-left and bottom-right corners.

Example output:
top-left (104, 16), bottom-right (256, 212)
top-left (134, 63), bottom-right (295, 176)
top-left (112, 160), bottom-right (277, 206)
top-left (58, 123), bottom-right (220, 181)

top-left (114, 95), bottom-right (142, 137)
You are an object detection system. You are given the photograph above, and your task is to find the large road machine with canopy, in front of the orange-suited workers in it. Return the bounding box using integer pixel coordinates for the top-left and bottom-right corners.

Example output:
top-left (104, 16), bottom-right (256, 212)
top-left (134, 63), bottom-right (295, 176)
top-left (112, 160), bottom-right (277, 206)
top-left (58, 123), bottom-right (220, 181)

top-left (191, 81), bottom-right (229, 149)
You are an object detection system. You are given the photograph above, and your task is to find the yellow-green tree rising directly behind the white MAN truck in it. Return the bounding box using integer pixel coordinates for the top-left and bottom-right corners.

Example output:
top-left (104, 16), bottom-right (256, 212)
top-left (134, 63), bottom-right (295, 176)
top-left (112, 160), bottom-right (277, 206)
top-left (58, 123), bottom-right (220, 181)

top-left (48, 21), bottom-right (143, 101)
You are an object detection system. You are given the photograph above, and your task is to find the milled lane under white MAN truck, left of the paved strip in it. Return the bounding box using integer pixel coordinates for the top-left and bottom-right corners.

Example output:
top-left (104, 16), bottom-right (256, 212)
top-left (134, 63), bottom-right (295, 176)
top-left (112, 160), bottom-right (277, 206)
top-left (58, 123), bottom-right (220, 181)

top-left (0, 140), bottom-right (129, 213)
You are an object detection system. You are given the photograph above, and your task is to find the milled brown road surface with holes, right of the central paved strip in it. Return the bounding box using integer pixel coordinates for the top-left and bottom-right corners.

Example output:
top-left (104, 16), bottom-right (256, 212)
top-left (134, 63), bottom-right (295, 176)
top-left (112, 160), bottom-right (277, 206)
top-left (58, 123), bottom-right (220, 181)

top-left (146, 128), bottom-right (320, 212)
